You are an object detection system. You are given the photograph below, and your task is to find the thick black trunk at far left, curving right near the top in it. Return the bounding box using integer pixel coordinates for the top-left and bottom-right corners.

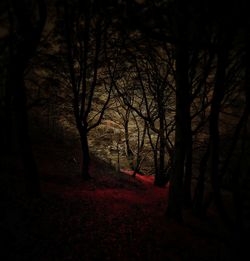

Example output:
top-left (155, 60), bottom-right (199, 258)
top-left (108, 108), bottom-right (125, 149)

top-left (7, 0), bottom-right (47, 196)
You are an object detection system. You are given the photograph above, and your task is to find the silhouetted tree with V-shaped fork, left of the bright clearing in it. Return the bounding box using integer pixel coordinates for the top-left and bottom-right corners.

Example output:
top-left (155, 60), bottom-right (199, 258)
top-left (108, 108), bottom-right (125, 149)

top-left (63, 1), bottom-right (115, 179)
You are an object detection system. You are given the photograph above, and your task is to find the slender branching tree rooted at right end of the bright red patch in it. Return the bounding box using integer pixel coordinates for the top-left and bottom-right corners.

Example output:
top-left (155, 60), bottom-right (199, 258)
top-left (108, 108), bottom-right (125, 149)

top-left (112, 41), bottom-right (173, 186)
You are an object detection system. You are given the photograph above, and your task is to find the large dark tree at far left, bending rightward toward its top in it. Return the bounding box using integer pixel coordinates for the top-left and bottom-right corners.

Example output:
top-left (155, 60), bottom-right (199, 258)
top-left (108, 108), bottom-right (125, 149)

top-left (5, 0), bottom-right (46, 195)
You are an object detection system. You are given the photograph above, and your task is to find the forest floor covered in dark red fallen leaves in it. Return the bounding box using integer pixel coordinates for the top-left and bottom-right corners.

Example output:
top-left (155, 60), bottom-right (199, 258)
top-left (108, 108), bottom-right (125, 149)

top-left (1, 131), bottom-right (242, 261)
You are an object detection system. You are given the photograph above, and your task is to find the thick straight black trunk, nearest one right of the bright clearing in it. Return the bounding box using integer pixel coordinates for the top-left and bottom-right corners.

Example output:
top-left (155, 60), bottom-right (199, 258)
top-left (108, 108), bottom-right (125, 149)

top-left (167, 0), bottom-right (189, 221)
